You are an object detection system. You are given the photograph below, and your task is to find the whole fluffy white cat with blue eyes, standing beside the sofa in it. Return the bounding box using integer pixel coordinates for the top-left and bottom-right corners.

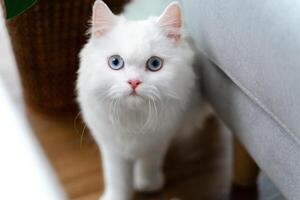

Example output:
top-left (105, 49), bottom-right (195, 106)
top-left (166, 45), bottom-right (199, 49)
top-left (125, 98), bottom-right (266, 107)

top-left (77, 0), bottom-right (205, 200)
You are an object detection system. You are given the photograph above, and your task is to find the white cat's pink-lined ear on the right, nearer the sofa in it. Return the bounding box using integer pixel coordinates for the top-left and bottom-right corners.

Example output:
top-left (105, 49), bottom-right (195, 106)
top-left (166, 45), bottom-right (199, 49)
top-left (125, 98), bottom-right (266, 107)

top-left (157, 2), bottom-right (182, 41)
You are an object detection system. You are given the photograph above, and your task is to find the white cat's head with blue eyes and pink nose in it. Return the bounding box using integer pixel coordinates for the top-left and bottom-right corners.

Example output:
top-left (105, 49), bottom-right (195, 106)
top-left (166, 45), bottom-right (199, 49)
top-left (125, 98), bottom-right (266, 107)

top-left (78, 0), bottom-right (195, 106)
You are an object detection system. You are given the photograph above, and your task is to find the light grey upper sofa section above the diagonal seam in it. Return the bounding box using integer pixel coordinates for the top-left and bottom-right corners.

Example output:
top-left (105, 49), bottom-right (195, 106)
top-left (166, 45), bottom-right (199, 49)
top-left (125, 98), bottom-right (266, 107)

top-left (183, 0), bottom-right (300, 146)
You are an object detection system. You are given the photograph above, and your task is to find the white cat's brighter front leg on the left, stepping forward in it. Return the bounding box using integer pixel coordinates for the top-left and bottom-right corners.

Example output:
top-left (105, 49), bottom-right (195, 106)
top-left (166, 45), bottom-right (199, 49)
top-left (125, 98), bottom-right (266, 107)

top-left (100, 147), bottom-right (133, 200)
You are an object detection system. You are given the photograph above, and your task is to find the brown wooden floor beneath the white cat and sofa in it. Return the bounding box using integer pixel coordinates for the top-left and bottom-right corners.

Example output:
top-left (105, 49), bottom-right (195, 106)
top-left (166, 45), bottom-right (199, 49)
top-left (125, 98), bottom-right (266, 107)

top-left (28, 110), bottom-right (283, 200)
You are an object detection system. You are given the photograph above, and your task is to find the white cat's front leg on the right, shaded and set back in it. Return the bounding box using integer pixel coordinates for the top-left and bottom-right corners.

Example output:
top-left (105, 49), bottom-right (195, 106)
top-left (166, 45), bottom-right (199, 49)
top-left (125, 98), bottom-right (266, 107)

top-left (134, 145), bottom-right (167, 192)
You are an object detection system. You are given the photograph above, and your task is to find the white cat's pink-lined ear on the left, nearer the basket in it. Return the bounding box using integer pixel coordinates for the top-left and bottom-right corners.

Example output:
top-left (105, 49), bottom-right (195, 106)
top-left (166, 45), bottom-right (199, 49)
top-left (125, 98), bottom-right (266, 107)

top-left (92, 0), bottom-right (116, 37)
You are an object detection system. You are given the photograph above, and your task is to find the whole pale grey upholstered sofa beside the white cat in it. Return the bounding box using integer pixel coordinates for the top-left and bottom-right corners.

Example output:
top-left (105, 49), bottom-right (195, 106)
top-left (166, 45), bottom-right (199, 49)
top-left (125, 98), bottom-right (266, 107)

top-left (182, 0), bottom-right (300, 200)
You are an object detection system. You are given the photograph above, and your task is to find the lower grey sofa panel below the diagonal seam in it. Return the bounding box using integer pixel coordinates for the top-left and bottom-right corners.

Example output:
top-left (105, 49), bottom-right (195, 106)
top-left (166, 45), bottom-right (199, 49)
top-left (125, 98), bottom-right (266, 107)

top-left (202, 57), bottom-right (300, 200)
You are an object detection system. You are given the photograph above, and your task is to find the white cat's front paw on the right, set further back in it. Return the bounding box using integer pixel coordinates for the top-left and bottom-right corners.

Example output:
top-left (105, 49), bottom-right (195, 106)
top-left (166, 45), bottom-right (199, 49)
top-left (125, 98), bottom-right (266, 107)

top-left (134, 172), bottom-right (165, 192)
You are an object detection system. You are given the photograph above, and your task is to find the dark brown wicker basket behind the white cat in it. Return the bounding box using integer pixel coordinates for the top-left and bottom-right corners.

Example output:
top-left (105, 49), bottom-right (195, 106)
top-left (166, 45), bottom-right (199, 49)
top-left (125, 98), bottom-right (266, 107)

top-left (7, 0), bottom-right (126, 111)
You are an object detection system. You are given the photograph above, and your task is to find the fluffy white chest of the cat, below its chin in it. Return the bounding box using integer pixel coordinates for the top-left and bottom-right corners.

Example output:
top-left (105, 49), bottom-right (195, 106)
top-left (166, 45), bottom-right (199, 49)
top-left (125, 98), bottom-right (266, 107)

top-left (84, 99), bottom-right (181, 156)
